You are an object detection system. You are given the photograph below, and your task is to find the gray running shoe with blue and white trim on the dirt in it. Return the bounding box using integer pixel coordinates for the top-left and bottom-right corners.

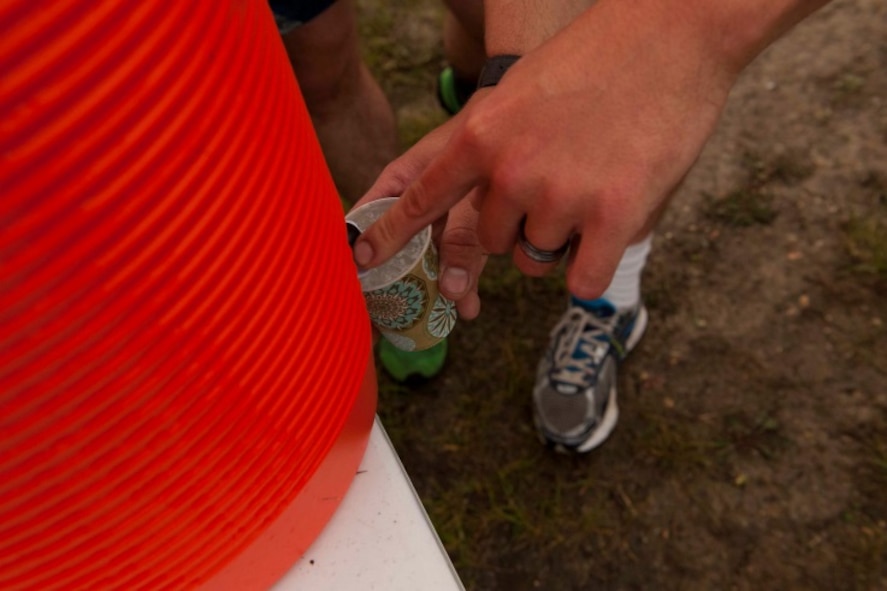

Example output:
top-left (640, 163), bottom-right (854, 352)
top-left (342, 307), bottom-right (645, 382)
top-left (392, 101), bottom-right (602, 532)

top-left (533, 299), bottom-right (647, 453)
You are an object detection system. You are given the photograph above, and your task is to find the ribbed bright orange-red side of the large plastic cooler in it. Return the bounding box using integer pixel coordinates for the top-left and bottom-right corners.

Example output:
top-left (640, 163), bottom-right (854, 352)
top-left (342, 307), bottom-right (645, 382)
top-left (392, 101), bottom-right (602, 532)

top-left (0, 0), bottom-right (370, 590)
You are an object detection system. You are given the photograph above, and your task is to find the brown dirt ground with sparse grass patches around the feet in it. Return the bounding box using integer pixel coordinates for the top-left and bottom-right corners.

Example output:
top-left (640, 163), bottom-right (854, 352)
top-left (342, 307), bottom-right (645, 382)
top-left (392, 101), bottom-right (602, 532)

top-left (360, 0), bottom-right (887, 591)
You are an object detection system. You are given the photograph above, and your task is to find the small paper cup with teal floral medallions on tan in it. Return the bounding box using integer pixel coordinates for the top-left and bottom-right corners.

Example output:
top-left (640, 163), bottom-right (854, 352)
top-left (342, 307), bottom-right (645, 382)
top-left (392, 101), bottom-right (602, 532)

top-left (345, 197), bottom-right (456, 351)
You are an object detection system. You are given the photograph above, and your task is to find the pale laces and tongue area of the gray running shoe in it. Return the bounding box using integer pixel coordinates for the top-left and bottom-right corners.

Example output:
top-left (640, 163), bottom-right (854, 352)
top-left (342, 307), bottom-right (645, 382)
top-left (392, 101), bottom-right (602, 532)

top-left (550, 306), bottom-right (619, 394)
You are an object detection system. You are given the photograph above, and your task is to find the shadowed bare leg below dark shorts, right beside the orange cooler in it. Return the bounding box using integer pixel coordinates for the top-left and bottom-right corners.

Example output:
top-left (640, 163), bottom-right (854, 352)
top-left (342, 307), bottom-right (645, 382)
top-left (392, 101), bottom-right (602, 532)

top-left (283, 0), bottom-right (398, 203)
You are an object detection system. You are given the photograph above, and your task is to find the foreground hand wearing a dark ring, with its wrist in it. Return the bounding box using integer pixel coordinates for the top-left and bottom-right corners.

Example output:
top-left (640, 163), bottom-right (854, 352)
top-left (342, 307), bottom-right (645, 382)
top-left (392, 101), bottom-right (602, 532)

top-left (355, 0), bottom-right (824, 306)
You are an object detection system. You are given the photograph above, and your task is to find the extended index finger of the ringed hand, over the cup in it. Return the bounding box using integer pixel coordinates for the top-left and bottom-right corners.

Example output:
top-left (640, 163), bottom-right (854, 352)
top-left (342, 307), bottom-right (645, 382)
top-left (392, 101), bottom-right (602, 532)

top-left (354, 142), bottom-right (480, 269)
